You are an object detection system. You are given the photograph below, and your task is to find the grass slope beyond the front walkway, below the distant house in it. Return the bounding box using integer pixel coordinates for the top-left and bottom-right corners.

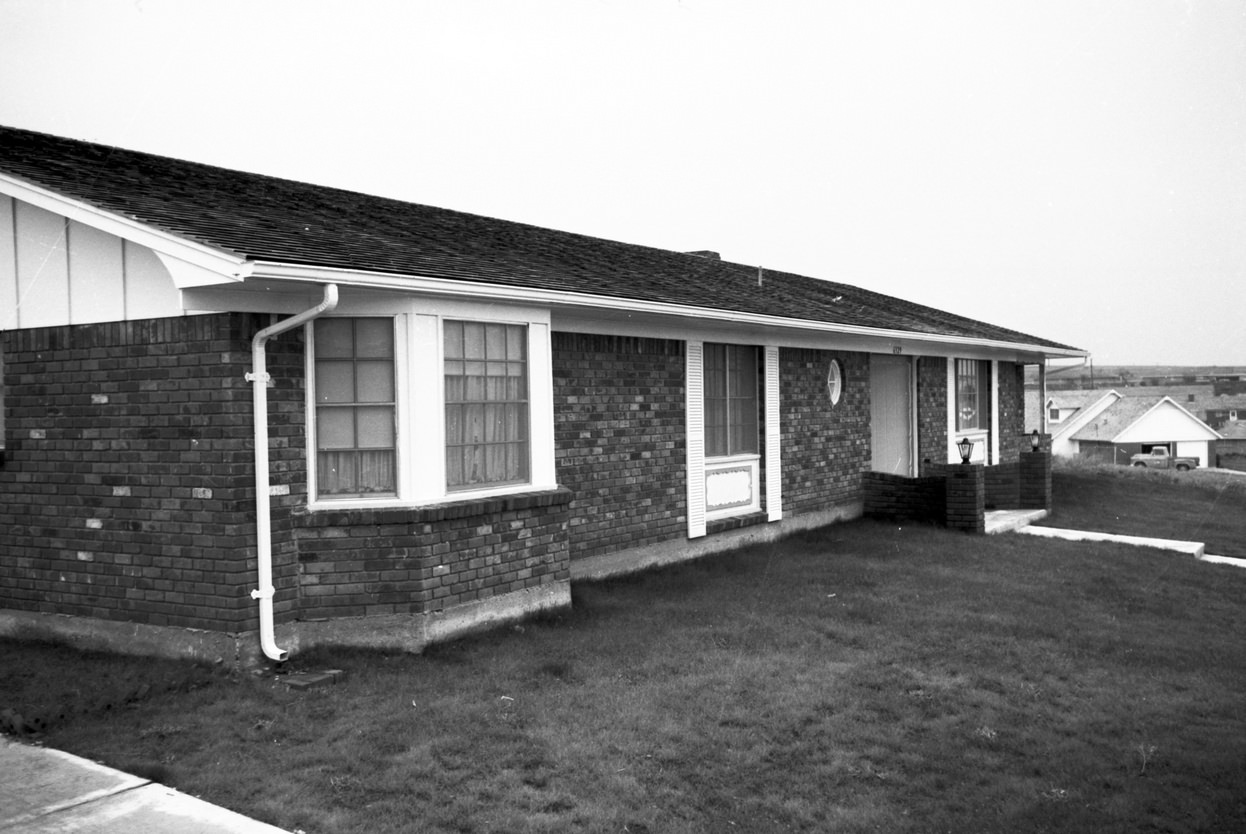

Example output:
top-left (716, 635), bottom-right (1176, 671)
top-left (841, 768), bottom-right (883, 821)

top-left (1040, 461), bottom-right (1246, 557)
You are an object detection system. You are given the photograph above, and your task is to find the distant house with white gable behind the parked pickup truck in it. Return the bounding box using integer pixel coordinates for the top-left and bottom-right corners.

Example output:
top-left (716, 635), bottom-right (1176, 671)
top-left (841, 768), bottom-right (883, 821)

top-left (1069, 396), bottom-right (1220, 466)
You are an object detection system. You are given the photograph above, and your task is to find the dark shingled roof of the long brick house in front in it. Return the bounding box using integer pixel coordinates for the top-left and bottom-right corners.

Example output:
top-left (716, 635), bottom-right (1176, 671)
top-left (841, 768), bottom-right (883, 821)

top-left (0, 127), bottom-right (1083, 355)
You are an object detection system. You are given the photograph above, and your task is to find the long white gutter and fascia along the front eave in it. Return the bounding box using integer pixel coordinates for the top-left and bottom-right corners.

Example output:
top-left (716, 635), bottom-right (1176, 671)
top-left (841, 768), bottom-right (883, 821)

top-left (253, 261), bottom-right (1088, 363)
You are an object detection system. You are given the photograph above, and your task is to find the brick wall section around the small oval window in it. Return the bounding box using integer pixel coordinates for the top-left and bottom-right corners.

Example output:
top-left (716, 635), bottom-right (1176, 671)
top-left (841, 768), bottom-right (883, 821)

top-left (779, 348), bottom-right (870, 516)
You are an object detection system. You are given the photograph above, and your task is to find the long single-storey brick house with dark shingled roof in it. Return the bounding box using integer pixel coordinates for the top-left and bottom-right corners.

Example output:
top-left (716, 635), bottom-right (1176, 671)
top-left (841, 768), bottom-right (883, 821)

top-left (0, 128), bottom-right (1084, 662)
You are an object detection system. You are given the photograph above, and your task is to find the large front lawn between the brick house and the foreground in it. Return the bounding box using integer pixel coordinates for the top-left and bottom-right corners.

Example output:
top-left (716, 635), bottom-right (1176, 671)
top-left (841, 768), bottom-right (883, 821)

top-left (7, 471), bottom-right (1246, 834)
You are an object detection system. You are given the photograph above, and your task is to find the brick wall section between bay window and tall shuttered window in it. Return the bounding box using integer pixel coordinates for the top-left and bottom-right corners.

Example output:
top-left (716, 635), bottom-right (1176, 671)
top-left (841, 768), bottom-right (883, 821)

top-left (553, 333), bottom-right (687, 558)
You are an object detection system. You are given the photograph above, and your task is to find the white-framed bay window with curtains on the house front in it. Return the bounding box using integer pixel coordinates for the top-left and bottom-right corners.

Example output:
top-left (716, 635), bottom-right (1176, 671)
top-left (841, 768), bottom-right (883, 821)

top-left (307, 304), bottom-right (557, 510)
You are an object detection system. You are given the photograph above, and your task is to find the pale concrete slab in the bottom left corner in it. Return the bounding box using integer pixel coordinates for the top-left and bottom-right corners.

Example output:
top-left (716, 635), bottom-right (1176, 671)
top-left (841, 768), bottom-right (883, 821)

top-left (0, 736), bottom-right (283, 834)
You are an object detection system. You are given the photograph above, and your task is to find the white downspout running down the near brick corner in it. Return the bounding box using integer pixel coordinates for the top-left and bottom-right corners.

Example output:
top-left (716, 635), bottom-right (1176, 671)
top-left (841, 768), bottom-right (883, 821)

top-left (247, 284), bottom-right (338, 663)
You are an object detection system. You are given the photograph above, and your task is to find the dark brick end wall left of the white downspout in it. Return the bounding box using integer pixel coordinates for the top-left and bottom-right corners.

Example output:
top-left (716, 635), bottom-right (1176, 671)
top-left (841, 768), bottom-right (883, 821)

top-left (0, 315), bottom-right (255, 631)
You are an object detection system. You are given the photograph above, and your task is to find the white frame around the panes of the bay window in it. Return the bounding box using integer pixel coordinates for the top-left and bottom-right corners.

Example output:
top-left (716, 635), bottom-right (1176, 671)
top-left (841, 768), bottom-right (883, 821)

top-left (305, 297), bottom-right (557, 511)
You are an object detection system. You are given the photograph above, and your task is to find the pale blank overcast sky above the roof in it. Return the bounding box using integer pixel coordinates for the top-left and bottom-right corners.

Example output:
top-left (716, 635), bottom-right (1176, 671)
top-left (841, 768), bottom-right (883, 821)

top-left (0, 0), bottom-right (1246, 365)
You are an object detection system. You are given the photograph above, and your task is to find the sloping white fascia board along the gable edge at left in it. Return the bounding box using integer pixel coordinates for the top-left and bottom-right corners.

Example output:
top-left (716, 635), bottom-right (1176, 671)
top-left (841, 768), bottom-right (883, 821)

top-left (0, 173), bottom-right (252, 280)
